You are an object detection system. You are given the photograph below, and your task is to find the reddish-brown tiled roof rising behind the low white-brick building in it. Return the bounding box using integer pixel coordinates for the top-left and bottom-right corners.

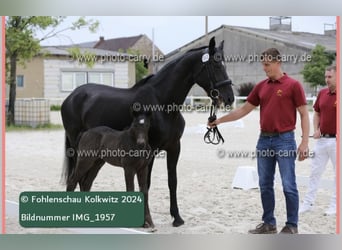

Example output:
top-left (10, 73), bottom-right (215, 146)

top-left (94, 35), bottom-right (143, 51)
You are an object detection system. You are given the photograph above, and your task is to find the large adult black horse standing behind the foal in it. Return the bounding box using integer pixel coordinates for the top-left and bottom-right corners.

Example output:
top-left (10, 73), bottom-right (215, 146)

top-left (61, 38), bottom-right (234, 226)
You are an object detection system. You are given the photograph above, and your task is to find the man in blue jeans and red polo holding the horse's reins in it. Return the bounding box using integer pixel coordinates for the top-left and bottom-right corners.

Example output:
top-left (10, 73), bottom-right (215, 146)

top-left (208, 48), bottom-right (310, 234)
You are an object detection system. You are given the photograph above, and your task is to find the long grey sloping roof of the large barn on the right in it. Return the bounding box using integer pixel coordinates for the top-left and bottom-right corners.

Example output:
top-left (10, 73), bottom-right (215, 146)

top-left (166, 25), bottom-right (336, 57)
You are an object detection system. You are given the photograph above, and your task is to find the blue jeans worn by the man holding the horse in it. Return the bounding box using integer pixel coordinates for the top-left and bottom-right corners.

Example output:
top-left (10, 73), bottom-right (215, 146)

top-left (257, 131), bottom-right (299, 227)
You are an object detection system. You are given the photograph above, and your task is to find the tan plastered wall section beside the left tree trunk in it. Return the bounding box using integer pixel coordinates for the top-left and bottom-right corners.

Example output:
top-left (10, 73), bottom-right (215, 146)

top-left (15, 58), bottom-right (44, 98)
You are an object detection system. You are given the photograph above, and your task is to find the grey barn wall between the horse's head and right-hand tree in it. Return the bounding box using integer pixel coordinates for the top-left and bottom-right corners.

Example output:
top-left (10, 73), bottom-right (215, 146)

top-left (223, 28), bottom-right (312, 93)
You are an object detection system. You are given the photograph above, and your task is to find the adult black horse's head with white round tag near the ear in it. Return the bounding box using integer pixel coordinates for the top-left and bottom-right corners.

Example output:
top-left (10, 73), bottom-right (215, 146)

top-left (194, 37), bottom-right (234, 105)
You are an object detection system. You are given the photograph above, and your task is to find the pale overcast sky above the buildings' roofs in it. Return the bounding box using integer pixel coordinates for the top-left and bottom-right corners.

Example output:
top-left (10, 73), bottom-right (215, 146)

top-left (37, 16), bottom-right (336, 54)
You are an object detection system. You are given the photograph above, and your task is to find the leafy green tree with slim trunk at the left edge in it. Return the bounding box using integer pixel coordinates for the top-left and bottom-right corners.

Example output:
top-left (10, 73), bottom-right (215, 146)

top-left (5, 16), bottom-right (99, 125)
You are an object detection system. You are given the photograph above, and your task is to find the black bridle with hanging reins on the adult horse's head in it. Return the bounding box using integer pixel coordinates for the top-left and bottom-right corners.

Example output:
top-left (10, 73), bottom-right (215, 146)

top-left (200, 50), bottom-right (232, 145)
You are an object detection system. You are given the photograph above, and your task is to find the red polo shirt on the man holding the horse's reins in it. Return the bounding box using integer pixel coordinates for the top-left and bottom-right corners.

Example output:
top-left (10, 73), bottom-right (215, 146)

top-left (247, 74), bottom-right (306, 133)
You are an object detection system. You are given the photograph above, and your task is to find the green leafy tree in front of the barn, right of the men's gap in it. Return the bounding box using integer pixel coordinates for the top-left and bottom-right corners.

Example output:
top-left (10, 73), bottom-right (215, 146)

top-left (301, 44), bottom-right (336, 93)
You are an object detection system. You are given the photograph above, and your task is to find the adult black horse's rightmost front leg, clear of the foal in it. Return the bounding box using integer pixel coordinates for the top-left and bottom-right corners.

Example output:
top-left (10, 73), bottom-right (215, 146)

top-left (167, 141), bottom-right (184, 227)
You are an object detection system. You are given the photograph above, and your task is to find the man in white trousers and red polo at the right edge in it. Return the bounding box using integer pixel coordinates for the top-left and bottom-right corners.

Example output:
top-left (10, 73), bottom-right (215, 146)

top-left (299, 66), bottom-right (336, 215)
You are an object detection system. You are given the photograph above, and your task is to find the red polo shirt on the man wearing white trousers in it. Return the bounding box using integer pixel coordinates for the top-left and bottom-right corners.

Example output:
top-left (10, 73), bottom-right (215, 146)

top-left (313, 88), bottom-right (336, 135)
